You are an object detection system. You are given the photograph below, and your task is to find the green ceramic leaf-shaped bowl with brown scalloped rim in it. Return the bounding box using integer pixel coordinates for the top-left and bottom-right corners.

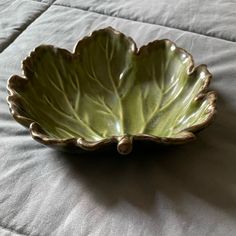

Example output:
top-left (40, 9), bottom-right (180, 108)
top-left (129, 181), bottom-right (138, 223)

top-left (7, 27), bottom-right (216, 154)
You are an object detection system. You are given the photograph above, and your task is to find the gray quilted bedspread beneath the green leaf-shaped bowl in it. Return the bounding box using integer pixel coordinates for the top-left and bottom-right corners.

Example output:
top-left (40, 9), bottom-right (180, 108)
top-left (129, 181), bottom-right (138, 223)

top-left (0, 0), bottom-right (236, 236)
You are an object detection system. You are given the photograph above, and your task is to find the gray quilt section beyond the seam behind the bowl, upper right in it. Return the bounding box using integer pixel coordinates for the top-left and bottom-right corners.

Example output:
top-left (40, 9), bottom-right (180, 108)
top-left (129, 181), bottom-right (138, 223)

top-left (55, 0), bottom-right (236, 41)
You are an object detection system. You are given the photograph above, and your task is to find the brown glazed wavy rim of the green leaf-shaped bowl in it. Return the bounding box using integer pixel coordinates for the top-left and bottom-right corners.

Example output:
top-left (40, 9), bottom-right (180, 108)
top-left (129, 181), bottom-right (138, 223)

top-left (7, 27), bottom-right (216, 154)
